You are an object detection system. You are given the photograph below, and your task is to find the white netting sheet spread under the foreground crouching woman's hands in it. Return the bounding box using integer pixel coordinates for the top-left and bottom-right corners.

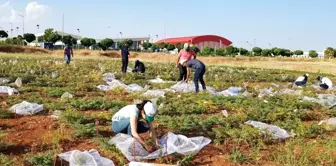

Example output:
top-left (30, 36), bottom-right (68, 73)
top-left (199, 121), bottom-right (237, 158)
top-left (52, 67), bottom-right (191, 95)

top-left (109, 132), bottom-right (211, 161)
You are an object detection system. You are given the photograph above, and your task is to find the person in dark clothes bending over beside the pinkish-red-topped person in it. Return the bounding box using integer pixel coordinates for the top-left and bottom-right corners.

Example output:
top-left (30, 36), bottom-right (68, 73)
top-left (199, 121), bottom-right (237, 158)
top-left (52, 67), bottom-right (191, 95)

top-left (182, 59), bottom-right (206, 93)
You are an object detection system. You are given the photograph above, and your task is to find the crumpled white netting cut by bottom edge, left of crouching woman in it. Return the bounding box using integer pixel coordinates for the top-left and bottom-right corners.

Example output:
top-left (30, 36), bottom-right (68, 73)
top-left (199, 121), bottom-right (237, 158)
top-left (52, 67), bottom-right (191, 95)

top-left (58, 149), bottom-right (114, 166)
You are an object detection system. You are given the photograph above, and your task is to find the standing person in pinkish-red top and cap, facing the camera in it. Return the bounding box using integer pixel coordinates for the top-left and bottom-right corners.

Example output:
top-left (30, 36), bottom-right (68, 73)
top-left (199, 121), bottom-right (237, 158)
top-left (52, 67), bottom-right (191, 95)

top-left (176, 43), bottom-right (196, 81)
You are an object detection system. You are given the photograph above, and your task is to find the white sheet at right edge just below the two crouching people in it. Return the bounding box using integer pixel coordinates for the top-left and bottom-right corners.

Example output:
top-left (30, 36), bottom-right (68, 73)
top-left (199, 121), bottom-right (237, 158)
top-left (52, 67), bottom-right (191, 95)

top-left (302, 94), bottom-right (336, 108)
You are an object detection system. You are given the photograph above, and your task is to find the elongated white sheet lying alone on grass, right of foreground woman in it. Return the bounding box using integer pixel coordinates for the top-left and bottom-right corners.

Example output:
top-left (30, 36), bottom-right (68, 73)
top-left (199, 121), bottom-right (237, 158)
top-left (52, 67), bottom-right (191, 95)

top-left (245, 120), bottom-right (295, 139)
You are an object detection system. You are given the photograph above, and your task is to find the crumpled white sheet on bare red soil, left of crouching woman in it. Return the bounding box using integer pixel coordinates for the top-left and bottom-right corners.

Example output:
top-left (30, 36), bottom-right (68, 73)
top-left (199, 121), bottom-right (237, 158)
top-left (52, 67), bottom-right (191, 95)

top-left (9, 101), bottom-right (43, 115)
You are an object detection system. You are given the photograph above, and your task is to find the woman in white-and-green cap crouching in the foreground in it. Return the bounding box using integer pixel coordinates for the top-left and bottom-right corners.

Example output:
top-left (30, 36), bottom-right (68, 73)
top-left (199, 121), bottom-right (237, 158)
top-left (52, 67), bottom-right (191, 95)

top-left (112, 100), bottom-right (159, 152)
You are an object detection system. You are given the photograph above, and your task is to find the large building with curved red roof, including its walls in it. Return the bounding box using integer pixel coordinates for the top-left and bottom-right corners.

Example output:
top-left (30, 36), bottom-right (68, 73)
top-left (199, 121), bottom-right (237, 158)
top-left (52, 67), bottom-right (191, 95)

top-left (156, 35), bottom-right (232, 50)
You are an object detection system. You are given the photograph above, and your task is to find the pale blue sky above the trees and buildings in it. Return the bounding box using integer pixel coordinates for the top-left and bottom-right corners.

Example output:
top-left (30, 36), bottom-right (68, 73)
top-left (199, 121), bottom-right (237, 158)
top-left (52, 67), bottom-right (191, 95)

top-left (0, 0), bottom-right (336, 51)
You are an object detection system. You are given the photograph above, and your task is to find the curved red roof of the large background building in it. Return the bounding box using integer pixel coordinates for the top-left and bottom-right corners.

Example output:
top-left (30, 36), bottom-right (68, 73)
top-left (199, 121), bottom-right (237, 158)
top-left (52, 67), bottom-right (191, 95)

top-left (156, 35), bottom-right (232, 46)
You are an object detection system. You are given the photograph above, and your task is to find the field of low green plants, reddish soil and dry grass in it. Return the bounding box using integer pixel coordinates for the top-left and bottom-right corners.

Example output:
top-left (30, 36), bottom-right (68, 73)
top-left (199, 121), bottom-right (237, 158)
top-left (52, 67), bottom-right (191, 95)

top-left (0, 52), bottom-right (336, 166)
